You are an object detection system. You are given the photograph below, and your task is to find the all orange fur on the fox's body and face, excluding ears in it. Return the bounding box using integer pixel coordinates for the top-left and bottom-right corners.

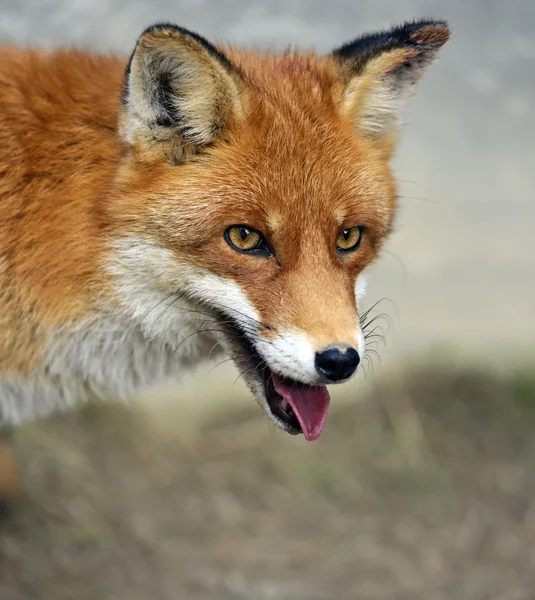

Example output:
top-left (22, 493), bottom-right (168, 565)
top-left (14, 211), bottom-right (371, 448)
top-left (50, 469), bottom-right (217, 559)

top-left (0, 50), bottom-right (394, 356)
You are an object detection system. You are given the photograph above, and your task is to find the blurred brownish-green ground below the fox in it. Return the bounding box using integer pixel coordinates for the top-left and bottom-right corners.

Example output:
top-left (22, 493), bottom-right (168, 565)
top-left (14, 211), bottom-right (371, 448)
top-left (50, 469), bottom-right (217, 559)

top-left (0, 371), bottom-right (535, 600)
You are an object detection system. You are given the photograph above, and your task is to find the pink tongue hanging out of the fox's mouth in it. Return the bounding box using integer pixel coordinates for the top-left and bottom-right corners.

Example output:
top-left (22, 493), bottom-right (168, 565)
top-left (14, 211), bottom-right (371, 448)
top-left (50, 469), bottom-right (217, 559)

top-left (273, 373), bottom-right (331, 442)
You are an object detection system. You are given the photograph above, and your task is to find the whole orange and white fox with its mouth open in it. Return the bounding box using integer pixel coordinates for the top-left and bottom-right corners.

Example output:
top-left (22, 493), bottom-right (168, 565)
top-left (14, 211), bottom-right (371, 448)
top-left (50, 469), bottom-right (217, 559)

top-left (0, 20), bottom-right (450, 502)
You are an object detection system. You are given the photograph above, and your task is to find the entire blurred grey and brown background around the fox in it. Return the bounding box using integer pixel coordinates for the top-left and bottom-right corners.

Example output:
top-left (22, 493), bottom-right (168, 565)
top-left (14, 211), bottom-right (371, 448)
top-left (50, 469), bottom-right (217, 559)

top-left (0, 0), bottom-right (535, 600)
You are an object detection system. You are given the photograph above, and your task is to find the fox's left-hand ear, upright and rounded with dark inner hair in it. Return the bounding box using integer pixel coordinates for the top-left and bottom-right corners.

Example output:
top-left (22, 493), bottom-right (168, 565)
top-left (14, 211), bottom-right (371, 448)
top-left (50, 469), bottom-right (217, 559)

top-left (122, 24), bottom-right (242, 162)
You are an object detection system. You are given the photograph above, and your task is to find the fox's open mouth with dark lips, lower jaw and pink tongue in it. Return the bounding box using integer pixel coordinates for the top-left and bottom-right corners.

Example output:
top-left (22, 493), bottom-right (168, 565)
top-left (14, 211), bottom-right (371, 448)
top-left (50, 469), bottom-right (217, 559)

top-left (225, 323), bottom-right (330, 441)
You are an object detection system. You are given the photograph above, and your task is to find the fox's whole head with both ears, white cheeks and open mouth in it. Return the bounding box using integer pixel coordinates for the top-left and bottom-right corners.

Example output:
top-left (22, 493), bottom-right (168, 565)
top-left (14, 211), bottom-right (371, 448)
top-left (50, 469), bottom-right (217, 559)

top-left (113, 21), bottom-right (449, 440)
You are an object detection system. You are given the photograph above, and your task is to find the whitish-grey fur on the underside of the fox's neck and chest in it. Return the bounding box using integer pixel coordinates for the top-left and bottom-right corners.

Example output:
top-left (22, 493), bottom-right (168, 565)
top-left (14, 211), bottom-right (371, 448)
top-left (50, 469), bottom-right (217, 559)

top-left (0, 316), bottom-right (221, 427)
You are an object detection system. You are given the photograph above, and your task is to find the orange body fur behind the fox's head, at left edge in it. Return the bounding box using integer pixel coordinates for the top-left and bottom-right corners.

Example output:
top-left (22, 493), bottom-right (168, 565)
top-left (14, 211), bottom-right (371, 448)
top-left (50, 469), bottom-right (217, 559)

top-left (0, 50), bottom-right (124, 373)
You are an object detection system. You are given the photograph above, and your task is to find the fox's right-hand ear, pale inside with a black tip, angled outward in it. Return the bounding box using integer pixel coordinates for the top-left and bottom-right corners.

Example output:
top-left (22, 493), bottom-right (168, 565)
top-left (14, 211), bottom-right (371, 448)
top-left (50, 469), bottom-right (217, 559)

top-left (331, 21), bottom-right (450, 152)
